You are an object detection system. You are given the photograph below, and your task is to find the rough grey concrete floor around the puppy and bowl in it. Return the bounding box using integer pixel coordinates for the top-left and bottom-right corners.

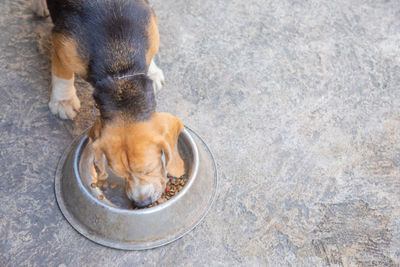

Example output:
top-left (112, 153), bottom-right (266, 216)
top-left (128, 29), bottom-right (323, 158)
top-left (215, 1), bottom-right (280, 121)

top-left (0, 0), bottom-right (400, 266)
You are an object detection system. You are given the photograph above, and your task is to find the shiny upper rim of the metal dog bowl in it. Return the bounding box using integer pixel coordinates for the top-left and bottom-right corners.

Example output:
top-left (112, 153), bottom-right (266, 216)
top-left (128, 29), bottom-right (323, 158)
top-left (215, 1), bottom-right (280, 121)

top-left (73, 127), bottom-right (200, 215)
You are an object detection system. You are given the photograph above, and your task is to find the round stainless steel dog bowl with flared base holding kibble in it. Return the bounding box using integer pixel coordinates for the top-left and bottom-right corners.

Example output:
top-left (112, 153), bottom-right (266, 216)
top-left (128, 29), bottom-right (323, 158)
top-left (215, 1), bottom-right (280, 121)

top-left (55, 128), bottom-right (217, 250)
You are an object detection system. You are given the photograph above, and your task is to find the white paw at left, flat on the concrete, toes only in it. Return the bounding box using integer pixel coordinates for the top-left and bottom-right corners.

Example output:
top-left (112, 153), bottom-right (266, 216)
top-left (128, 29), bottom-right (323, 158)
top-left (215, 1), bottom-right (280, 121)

top-left (49, 95), bottom-right (81, 120)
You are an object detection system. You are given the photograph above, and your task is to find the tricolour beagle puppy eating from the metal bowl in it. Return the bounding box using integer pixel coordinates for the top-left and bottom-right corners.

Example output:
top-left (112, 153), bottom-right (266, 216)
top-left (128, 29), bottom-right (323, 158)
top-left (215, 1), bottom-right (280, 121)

top-left (33, 0), bottom-right (184, 207)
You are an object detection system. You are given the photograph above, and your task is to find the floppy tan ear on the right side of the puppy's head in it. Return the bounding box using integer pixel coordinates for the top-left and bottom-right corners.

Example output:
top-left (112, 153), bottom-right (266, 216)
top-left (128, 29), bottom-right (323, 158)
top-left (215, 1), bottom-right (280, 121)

top-left (159, 113), bottom-right (185, 177)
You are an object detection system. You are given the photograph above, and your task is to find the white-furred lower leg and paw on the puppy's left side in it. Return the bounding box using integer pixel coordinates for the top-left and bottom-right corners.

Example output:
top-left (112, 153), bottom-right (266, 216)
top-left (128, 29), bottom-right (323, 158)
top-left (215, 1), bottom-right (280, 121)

top-left (49, 74), bottom-right (81, 120)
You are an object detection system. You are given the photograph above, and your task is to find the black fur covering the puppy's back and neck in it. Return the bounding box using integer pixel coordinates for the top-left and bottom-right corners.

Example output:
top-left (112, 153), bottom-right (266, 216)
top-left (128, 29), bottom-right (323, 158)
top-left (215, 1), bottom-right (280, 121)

top-left (47, 0), bottom-right (156, 120)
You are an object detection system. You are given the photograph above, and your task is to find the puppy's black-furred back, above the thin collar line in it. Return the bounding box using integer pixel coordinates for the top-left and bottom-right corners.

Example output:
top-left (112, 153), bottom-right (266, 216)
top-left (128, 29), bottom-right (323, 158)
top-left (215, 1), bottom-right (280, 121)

top-left (47, 0), bottom-right (152, 80)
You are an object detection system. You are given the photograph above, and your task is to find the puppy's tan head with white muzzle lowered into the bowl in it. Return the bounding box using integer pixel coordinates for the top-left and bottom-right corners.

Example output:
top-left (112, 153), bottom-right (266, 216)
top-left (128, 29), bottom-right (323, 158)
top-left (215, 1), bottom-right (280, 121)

top-left (88, 113), bottom-right (184, 207)
